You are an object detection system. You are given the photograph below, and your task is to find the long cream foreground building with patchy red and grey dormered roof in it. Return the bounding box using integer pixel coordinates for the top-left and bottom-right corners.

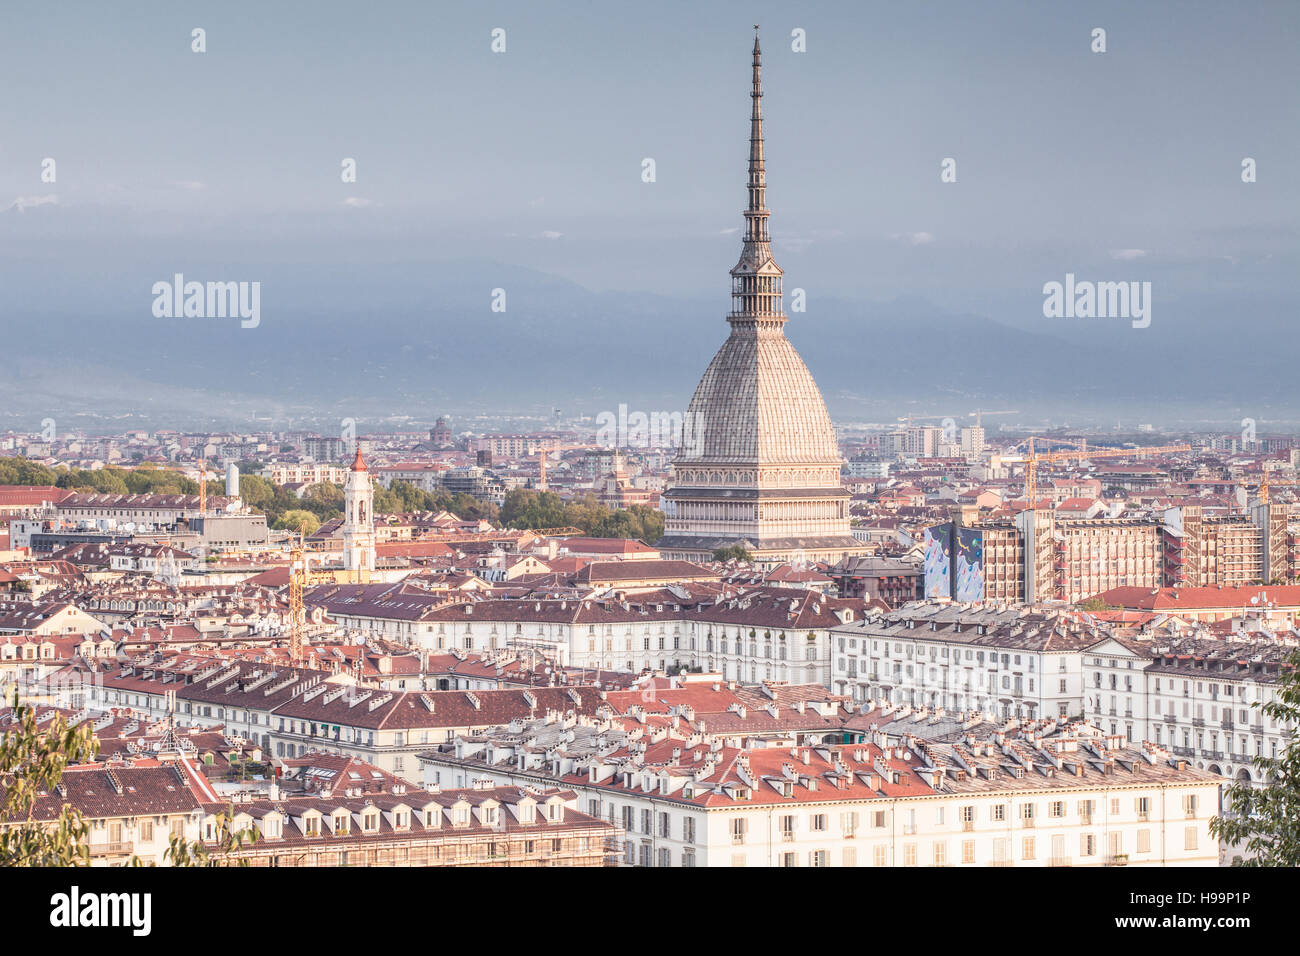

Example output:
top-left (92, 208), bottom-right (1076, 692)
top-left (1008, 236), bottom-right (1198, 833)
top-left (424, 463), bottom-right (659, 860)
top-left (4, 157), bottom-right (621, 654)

top-left (420, 721), bottom-right (1219, 868)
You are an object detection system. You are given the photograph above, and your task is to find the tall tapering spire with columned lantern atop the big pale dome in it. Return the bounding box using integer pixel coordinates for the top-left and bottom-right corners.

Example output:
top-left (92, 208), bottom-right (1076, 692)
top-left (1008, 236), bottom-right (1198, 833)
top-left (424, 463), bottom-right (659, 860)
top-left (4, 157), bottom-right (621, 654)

top-left (727, 23), bottom-right (785, 330)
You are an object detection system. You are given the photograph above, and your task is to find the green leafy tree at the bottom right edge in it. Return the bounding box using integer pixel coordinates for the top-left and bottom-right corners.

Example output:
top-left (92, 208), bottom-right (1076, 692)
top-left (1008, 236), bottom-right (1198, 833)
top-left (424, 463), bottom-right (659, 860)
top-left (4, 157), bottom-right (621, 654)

top-left (1210, 650), bottom-right (1300, 866)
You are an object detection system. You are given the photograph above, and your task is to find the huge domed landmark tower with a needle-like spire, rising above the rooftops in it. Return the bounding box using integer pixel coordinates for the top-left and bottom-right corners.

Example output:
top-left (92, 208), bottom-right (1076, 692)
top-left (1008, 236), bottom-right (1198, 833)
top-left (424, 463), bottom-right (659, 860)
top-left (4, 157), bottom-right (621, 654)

top-left (658, 29), bottom-right (866, 564)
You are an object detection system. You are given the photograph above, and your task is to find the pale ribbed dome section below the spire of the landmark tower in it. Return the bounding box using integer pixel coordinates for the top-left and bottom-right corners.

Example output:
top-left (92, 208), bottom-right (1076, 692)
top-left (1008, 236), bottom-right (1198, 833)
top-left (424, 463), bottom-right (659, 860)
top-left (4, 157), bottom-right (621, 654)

top-left (676, 329), bottom-right (840, 467)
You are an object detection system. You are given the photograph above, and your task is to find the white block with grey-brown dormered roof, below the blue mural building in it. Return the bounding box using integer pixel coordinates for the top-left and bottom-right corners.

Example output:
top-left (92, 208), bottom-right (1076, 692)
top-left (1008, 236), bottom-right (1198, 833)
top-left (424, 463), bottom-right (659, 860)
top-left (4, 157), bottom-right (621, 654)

top-left (829, 604), bottom-right (1105, 718)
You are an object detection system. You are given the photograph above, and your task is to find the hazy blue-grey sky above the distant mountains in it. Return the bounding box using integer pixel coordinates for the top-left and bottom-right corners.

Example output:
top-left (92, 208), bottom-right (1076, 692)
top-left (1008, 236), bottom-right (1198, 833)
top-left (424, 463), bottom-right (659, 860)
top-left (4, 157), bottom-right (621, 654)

top-left (0, 0), bottom-right (1300, 434)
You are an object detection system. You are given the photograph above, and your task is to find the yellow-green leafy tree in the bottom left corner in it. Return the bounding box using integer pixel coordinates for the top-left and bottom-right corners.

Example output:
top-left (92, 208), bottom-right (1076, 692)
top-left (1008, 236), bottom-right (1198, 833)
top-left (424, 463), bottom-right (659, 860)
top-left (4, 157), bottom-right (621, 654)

top-left (0, 689), bottom-right (99, 866)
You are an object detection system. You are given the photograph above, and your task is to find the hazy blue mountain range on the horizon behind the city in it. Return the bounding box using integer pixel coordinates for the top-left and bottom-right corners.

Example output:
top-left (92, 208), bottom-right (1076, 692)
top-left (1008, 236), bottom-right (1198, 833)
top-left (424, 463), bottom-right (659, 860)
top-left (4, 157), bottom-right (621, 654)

top-left (0, 239), bottom-right (1300, 429)
